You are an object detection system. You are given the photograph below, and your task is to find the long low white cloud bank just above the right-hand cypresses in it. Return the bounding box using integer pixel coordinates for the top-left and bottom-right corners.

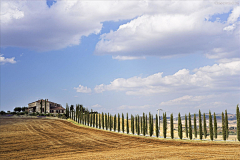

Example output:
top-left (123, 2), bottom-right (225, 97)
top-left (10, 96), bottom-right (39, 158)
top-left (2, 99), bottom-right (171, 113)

top-left (94, 59), bottom-right (240, 95)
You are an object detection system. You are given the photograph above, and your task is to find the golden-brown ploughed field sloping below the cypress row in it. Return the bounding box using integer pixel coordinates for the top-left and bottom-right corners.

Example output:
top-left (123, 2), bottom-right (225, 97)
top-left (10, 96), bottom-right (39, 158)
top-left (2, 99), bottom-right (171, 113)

top-left (0, 118), bottom-right (240, 159)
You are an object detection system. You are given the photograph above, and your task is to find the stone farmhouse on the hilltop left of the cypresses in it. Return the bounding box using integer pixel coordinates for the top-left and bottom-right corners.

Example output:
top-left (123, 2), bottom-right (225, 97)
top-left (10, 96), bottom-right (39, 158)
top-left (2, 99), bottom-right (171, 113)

top-left (28, 99), bottom-right (66, 114)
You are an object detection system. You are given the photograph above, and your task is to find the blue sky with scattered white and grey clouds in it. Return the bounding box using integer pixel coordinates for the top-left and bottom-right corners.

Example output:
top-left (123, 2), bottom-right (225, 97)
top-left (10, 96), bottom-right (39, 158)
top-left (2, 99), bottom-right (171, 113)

top-left (0, 0), bottom-right (240, 116)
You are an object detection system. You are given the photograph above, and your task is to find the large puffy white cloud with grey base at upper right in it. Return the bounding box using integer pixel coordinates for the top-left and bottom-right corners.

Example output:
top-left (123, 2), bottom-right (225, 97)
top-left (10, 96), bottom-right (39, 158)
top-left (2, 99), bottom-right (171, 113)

top-left (95, 1), bottom-right (240, 58)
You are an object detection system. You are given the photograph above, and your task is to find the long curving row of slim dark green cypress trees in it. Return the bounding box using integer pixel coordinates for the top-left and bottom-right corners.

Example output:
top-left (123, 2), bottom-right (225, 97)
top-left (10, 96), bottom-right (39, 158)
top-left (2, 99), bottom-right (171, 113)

top-left (66, 103), bottom-right (240, 141)
